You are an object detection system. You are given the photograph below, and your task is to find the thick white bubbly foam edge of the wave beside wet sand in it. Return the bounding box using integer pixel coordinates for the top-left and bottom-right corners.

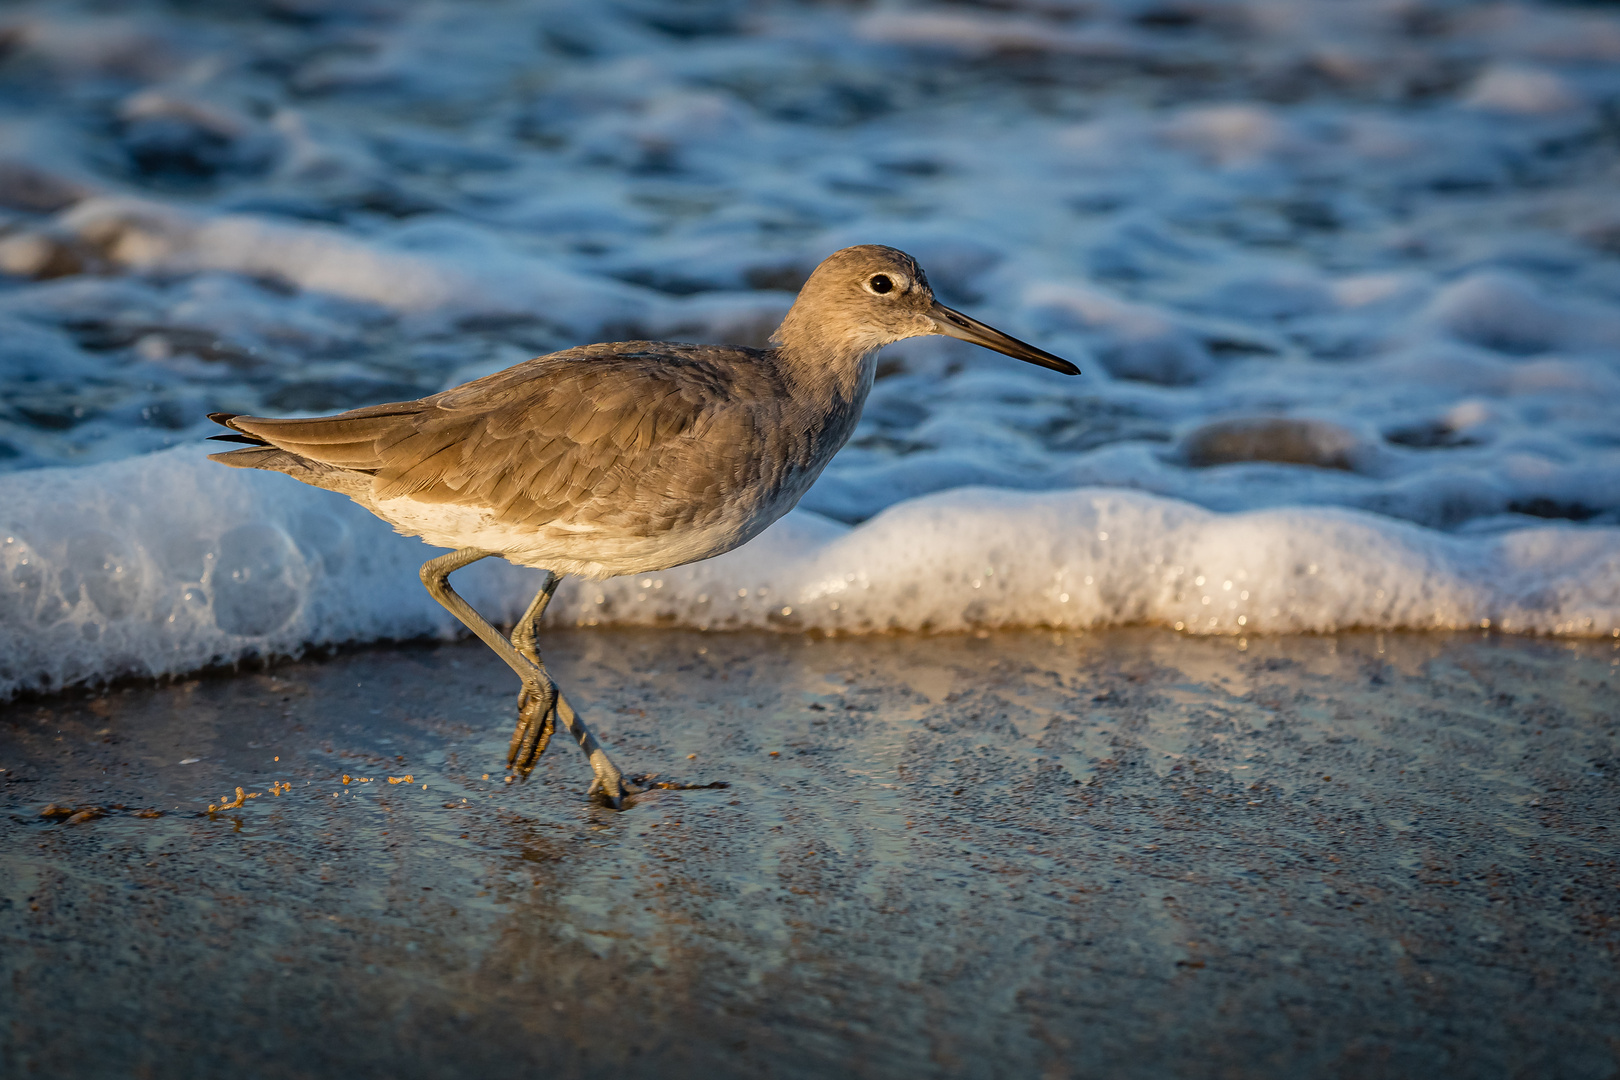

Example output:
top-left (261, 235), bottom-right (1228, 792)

top-left (0, 447), bottom-right (1620, 696)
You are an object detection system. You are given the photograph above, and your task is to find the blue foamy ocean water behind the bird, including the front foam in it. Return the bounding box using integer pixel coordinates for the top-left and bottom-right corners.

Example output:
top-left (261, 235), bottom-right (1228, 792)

top-left (0, 0), bottom-right (1620, 695)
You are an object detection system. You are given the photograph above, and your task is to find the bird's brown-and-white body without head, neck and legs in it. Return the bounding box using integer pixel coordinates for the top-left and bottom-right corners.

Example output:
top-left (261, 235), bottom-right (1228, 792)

top-left (214, 342), bottom-right (860, 576)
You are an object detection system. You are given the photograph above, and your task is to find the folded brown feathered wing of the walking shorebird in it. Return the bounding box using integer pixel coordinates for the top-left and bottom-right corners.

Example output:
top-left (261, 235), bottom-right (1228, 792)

top-left (221, 343), bottom-right (761, 528)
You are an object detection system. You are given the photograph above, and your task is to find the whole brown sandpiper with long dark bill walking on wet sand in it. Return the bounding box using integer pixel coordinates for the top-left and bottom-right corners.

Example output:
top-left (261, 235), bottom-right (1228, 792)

top-left (212, 244), bottom-right (1079, 805)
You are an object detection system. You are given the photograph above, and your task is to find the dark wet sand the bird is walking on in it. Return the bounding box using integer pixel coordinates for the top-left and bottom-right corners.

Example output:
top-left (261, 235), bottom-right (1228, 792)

top-left (0, 630), bottom-right (1620, 1077)
